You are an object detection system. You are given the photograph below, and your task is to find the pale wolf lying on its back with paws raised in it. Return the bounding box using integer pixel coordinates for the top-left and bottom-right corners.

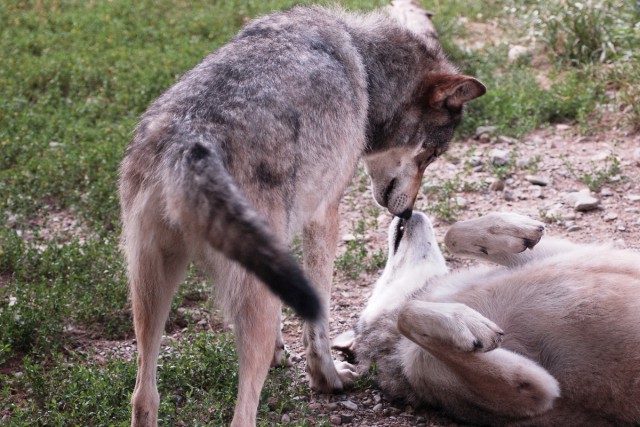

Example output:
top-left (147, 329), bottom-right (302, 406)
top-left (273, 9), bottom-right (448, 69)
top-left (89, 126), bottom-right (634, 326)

top-left (334, 213), bottom-right (640, 427)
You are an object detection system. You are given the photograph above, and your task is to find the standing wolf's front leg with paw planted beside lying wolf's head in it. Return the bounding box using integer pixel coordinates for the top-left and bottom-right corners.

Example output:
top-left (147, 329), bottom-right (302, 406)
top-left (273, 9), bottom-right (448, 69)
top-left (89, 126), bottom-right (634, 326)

top-left (302, 202), bottom-right (356, 392)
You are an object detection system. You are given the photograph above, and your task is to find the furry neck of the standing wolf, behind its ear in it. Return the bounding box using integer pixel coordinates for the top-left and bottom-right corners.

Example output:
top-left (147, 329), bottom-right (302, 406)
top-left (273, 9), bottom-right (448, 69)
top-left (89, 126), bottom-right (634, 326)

top-left (347, 13), bottom-right (457, 154)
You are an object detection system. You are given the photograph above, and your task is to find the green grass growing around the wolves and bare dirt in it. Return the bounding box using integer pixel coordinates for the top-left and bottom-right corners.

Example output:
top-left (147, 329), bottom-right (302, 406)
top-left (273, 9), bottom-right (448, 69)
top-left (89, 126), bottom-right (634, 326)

top-left (0, 0), bottom-right (640, 426)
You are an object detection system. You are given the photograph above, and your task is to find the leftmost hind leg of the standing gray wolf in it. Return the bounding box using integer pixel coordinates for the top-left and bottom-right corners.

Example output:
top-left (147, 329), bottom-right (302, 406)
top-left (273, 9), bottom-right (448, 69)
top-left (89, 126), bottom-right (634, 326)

top-left (125, 213), bottom-right (188, 427)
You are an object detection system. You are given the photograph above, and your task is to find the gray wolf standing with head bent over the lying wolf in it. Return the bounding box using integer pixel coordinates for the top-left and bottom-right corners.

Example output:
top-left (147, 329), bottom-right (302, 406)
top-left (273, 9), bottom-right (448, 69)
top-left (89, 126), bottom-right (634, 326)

top-left (120, 1), bottom-right (485, 426)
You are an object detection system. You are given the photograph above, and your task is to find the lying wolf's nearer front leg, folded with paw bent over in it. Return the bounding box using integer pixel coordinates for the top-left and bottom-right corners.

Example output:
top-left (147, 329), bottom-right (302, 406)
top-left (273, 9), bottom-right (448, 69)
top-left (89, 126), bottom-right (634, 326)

top-left (398, 301), bottom-right (560, 419)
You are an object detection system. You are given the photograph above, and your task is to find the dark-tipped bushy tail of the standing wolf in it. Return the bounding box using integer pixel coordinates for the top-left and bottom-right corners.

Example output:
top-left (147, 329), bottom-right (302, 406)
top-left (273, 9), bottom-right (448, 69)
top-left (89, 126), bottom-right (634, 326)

top-left (165, 138), bottom-right (321, 321)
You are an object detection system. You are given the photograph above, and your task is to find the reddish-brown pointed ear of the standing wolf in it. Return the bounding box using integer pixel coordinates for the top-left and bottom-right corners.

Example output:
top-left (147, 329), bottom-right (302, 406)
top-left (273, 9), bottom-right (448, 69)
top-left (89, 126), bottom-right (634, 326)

top-left (425, 74), bottom-right (487, 109)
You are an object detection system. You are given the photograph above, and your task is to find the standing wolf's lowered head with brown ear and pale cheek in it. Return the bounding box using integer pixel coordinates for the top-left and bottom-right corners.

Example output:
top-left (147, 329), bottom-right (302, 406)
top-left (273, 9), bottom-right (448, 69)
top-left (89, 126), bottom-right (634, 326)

top-left (364, 74), bottom-right (486, 219)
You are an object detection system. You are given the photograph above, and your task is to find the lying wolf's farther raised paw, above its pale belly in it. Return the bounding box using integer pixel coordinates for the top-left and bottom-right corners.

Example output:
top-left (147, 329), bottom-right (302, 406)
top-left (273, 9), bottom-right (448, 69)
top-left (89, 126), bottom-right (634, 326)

top-left (444, 212), bottom-right (544, 258)
